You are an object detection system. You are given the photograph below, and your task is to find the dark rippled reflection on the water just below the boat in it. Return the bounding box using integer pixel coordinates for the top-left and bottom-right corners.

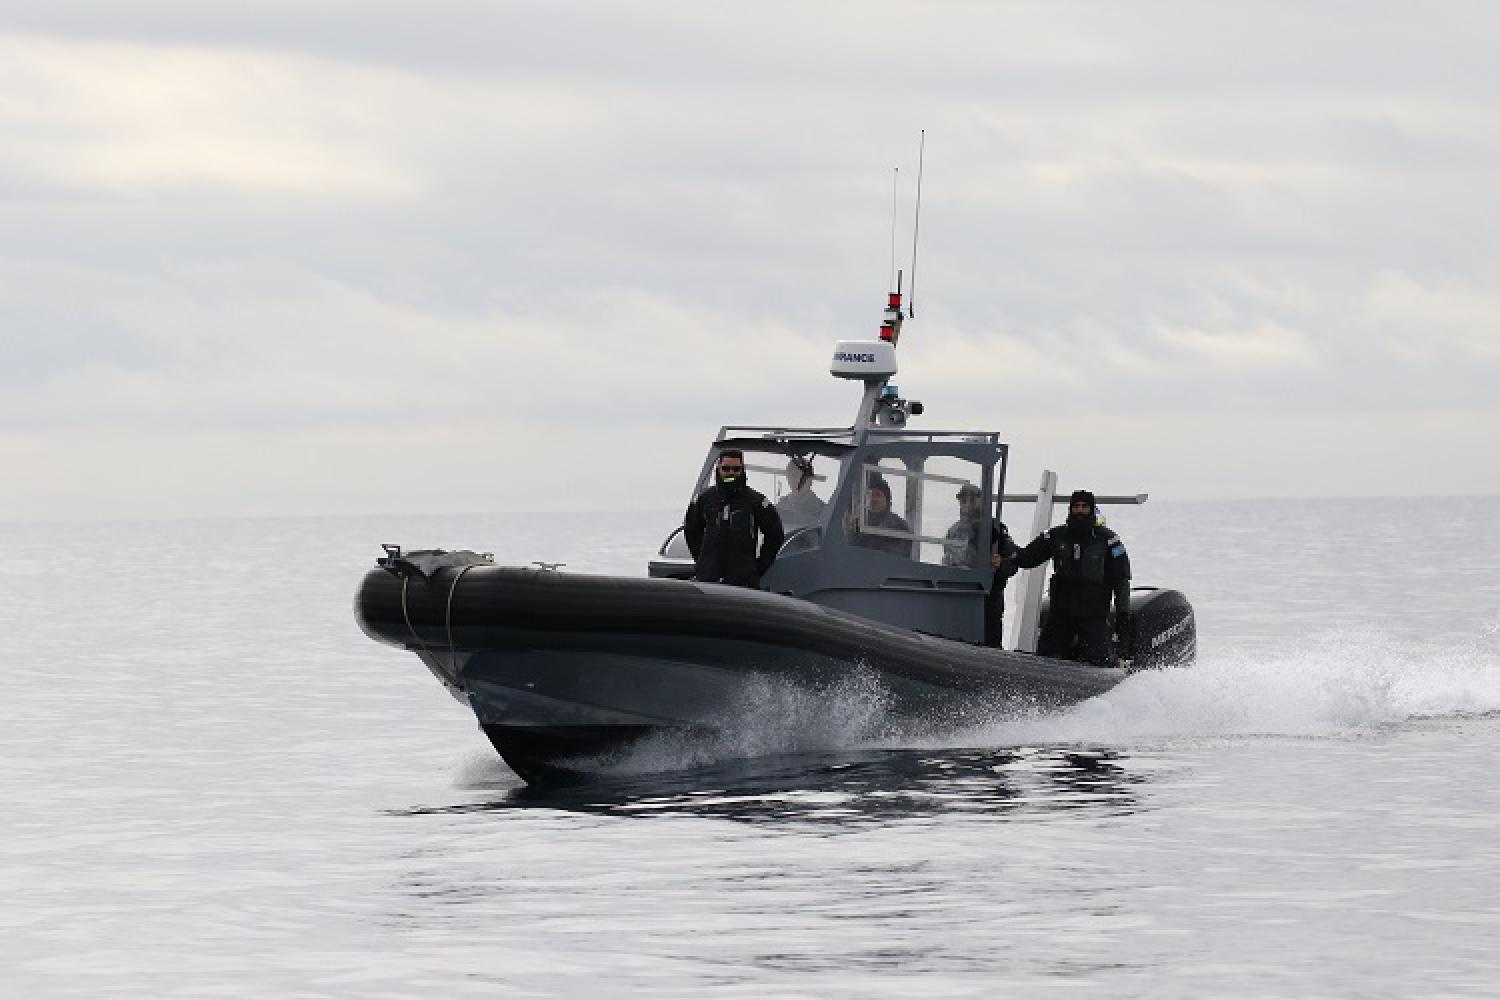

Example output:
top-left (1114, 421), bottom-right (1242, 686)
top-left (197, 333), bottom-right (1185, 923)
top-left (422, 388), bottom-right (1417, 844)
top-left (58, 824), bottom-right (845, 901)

top-left (398, 747), bottom-right (1145, 826)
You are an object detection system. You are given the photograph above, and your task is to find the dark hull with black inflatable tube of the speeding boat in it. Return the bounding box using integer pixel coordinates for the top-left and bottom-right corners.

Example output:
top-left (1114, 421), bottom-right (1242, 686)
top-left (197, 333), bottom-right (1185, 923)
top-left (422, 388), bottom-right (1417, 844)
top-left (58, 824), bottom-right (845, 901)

top-left (356, 562), bottom-right (1125, 781)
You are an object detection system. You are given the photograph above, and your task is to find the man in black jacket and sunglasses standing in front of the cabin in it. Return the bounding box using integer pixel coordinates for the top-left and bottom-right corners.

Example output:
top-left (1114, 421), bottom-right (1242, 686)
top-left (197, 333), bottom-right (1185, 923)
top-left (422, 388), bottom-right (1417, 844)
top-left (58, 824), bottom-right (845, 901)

top-left (683, 448), bottom-right (786, 588)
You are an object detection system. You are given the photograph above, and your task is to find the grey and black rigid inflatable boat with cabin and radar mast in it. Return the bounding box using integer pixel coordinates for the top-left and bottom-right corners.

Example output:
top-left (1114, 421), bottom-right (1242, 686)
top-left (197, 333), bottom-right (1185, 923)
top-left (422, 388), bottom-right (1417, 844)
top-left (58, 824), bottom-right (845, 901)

top-left (356, 284), bottom-right (1196, 781)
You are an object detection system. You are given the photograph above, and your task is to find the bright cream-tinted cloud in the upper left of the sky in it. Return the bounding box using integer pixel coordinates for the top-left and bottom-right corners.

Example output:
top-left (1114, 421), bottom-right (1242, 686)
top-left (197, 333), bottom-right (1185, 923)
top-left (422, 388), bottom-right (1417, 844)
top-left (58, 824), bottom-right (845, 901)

top-left (0, 36), bottom-right (425, 198)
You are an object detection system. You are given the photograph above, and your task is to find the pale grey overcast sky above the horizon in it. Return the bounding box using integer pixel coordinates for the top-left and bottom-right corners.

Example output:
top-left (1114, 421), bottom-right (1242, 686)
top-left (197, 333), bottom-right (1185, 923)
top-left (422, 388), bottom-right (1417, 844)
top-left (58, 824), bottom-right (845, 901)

top-left (0, 0), bottom-right (1500, 520)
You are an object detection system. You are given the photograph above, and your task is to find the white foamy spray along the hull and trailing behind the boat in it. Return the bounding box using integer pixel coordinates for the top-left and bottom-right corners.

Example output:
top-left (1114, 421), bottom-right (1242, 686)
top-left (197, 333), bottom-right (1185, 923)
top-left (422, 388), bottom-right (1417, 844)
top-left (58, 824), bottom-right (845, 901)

top-left (645, 630), bottom-right (1500, 771)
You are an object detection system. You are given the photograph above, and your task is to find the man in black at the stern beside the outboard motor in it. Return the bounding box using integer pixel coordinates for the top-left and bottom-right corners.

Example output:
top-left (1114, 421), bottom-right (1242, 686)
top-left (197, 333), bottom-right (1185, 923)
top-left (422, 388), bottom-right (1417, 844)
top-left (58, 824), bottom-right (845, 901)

top-left (1016, 490), bottom-right (1130, 667)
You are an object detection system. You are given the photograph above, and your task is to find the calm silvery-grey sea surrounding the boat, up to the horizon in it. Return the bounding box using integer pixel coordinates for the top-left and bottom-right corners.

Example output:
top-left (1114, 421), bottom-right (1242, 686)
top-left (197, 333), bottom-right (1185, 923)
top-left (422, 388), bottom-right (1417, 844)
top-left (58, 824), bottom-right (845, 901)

top-left (0, 499), bottom-right (1500, 999)
